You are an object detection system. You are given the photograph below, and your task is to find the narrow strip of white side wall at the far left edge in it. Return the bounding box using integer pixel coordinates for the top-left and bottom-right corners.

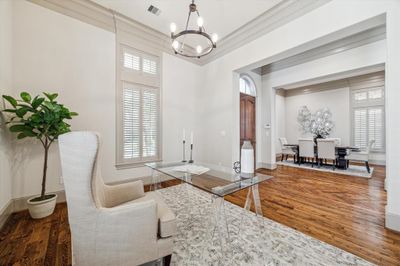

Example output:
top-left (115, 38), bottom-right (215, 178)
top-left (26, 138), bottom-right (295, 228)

top-left (0, 1), bottom-right (13, 211)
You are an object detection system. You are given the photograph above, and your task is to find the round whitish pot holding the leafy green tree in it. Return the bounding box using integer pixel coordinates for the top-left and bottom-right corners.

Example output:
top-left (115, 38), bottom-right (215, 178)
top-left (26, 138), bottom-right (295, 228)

top-left (27, 194), bottom-right (57, 219)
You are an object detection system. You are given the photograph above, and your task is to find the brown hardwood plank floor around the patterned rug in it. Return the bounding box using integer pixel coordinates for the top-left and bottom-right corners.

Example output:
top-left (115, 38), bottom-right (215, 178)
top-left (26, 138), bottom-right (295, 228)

top-left (0, 163), bottom-right (400, 265)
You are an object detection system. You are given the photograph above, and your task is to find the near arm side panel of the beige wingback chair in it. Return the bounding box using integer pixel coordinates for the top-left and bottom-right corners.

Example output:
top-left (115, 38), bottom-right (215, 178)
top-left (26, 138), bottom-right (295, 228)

top-left (95, 199), bottom-right (159, 265)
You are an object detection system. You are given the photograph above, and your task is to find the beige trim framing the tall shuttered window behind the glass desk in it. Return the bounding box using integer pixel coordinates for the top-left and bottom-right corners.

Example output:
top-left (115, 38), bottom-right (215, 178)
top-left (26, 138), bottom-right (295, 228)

top-left (115, 43), bottom-right (163, 169)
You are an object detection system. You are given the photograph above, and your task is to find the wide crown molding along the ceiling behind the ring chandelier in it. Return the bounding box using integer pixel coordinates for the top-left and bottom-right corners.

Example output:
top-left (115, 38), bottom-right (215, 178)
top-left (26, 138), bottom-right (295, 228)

top-left (27, 0), bottom-right (331, 65)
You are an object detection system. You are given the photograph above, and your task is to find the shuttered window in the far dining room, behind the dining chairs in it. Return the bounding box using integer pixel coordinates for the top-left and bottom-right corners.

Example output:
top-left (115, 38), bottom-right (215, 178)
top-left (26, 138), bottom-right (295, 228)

top-left (351, 86), bottom-right (385, 152)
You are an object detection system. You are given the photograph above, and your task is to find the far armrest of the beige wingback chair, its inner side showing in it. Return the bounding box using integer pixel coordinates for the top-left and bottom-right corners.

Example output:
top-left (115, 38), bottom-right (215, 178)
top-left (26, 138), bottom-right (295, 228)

top-left (104, 180), bottom-right (144, 208)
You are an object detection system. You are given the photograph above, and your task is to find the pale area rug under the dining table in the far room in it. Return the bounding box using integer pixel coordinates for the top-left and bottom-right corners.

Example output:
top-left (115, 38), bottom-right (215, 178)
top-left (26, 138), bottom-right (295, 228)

top-left (276, 161), bottom-right (374, 178)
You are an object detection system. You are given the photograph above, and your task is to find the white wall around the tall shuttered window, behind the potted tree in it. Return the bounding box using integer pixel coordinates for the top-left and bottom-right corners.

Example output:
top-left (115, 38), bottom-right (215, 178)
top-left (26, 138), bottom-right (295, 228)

top-left (9, 1), bottom-right (201, 198)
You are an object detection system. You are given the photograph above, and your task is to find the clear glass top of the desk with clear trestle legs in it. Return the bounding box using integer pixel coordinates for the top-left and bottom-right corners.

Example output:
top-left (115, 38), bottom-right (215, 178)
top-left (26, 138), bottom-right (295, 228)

top-left (146, 162), bottom-right (272, 197)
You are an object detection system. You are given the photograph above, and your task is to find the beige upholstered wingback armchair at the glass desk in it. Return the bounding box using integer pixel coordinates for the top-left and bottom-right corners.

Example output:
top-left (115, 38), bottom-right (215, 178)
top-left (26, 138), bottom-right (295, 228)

top-left (59, 132), bottom-right (177, 265)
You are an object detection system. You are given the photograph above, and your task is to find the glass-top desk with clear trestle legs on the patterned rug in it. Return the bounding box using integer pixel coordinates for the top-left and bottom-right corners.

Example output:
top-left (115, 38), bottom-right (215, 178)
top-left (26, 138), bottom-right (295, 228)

top-left (146, 162), bottom-right (272, 260)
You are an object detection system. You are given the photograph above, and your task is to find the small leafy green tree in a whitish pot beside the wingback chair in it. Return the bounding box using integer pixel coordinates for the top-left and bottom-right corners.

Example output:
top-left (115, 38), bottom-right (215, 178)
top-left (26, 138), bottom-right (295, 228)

top-left (3, 92), bottom-right (78, 219)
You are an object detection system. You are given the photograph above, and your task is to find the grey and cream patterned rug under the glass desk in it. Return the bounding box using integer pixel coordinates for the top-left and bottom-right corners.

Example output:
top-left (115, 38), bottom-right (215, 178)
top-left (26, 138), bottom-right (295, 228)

top-left (158, 185), bottom-right (372, 265)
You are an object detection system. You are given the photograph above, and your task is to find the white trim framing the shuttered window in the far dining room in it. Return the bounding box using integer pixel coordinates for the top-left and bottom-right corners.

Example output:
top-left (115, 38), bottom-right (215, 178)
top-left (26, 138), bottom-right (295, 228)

top-left (349, 84), bottom-right (386, 153)
